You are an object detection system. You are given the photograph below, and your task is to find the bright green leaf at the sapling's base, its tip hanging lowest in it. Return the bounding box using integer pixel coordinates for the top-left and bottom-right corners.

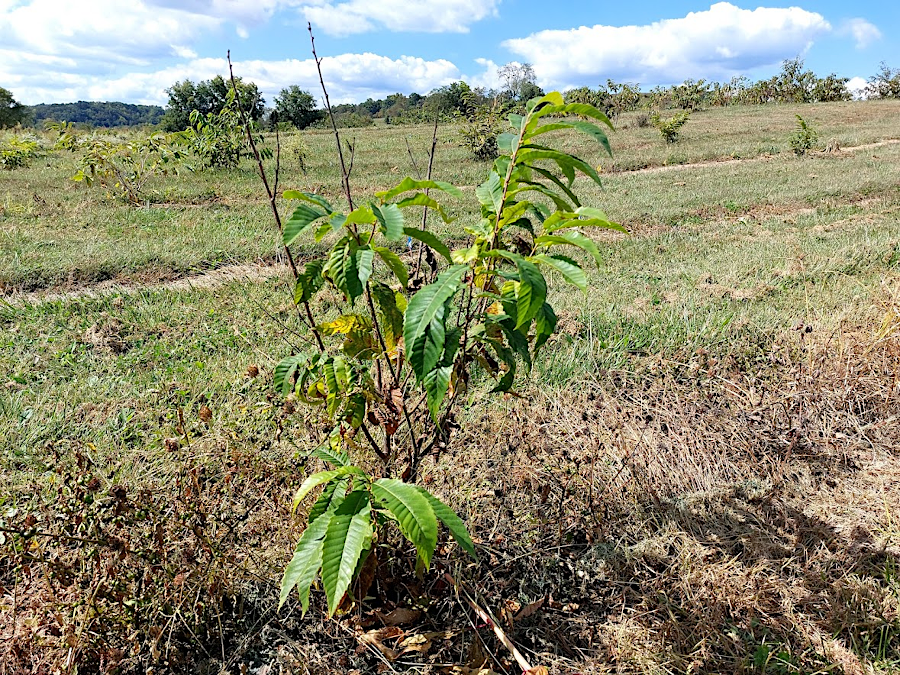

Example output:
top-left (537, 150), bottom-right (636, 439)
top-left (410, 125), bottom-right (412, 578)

top-left (322, 490), bottom-right (372, 616)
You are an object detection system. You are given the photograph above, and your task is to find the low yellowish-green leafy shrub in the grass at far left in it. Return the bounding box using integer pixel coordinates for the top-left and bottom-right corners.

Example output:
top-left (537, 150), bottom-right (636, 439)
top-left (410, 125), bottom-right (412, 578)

top-left (69, 127), bottom-right (185, 205)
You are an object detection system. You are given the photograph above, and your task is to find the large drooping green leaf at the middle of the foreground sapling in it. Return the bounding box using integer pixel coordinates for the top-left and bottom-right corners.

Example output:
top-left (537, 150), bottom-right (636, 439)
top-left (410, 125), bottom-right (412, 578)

top-left (403, 265), bottom-right (468, 382)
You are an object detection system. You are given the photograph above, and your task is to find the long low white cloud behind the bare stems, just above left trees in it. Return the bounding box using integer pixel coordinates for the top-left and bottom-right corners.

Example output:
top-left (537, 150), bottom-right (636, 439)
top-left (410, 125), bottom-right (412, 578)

top-left (0, 50), bottom-right (462, 105)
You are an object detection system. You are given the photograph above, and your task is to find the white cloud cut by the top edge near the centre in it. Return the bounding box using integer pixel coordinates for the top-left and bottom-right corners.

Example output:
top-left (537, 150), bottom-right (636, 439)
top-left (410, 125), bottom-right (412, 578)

top-left (301, 0), bottom-right (500, 35)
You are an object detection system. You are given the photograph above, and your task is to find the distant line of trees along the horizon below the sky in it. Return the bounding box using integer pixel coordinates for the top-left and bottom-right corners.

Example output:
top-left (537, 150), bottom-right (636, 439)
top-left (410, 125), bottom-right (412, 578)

top-left (0, 58), bottom-right (900, 131)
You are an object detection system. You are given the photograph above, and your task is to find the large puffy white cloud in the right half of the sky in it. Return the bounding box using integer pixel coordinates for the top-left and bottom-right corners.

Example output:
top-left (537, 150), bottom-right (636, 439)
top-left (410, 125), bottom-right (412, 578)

top-left (503, 2), bottom-right (832, 88)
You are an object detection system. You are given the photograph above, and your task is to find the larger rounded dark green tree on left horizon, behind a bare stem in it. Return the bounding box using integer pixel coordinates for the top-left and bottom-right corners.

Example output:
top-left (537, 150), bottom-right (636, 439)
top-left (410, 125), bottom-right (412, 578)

top-left (161, 75), bottom-right (266, 131)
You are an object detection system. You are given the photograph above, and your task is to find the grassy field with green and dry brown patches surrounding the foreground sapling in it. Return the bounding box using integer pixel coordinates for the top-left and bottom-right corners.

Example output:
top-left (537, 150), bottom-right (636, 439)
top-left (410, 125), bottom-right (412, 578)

top-left (0, 101), bottom-right (900, 674)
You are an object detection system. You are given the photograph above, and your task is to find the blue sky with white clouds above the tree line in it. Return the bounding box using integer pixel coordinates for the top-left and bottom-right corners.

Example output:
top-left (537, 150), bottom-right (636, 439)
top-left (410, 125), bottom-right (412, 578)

top-left (0, 0), bottom-right (900, 104)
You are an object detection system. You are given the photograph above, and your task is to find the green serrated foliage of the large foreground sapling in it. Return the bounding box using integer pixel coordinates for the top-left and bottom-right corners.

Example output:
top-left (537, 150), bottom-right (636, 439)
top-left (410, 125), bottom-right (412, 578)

top-left (275, 92), bottom-right (622, 614)
